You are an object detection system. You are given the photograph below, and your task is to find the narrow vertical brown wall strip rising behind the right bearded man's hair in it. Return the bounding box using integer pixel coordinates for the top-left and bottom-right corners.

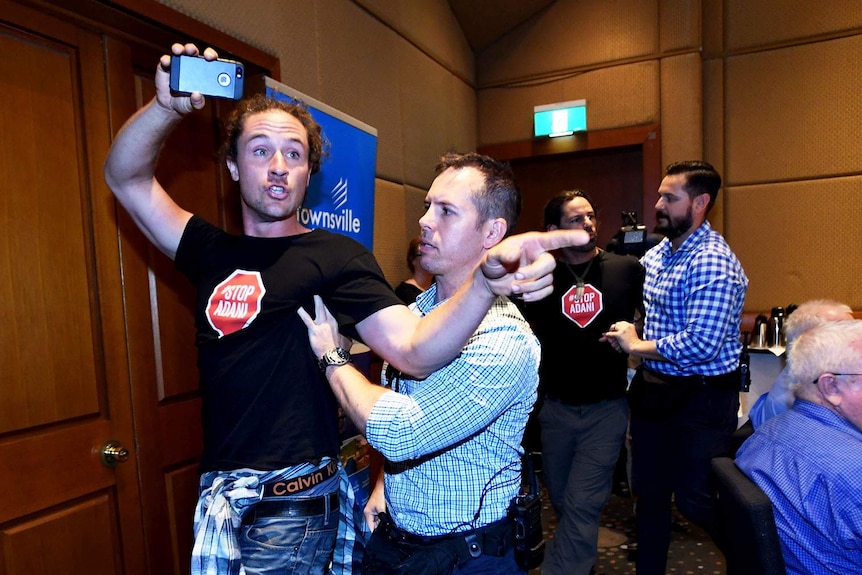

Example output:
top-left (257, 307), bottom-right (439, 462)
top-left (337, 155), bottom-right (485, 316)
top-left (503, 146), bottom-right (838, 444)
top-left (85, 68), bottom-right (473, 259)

top-left (704, 60), bottom-right (727, 232)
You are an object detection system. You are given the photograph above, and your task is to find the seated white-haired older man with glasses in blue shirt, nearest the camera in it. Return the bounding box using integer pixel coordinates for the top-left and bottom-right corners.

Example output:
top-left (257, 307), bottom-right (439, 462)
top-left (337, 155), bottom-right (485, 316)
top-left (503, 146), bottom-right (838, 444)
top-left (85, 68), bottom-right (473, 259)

top-left (736, 320), bottom-right (862, 575)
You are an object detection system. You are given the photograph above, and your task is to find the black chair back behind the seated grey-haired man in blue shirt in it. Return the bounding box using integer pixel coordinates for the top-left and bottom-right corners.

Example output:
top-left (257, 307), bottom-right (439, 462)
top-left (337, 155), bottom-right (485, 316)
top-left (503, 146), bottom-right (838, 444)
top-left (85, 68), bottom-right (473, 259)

top-left (712, 457), bottom-right (787, 575)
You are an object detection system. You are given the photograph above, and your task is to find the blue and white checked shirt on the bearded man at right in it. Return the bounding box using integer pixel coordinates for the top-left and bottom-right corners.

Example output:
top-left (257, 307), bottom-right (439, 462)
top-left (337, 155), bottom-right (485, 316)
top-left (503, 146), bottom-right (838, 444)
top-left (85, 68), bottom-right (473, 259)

top-left (641, 222), bottom-right (748, 375)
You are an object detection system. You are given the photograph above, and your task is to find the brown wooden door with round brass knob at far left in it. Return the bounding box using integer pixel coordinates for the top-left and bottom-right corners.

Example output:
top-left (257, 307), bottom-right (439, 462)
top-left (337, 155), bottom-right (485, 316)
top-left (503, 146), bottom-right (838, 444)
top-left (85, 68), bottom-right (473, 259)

top-left (0, 0), bottom-right (146, 575)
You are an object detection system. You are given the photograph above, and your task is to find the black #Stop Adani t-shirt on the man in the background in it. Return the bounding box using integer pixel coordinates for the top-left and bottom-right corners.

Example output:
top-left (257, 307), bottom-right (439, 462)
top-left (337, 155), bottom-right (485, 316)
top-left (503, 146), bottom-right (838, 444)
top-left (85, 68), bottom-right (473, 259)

top-left (525, 251), bottom-right (644, 405)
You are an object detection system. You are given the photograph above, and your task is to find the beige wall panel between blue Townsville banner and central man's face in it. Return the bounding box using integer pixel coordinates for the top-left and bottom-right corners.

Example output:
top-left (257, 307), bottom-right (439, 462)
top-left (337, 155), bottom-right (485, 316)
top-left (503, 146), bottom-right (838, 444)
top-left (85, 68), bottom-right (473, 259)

top-left (374, 178), bottom-right (413, 285)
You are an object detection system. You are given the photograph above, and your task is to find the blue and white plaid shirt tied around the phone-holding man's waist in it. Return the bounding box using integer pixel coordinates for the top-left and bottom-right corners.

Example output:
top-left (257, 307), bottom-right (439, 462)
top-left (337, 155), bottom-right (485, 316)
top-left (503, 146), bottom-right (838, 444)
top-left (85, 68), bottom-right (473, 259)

top-left (191, 458), bottom-right (356, 575)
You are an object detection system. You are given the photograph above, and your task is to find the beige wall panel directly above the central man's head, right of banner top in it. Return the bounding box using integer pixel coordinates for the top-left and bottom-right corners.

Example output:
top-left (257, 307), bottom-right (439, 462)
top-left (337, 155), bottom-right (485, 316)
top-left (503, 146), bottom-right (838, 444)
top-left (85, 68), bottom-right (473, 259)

top-left (398, 48), bottom-right (460, 187)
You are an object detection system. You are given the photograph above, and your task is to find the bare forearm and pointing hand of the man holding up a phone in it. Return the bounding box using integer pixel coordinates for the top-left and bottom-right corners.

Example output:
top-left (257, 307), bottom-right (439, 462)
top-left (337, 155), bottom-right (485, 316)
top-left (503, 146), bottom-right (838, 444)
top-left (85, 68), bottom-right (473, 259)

top-left (357, 230), bottom-right (589, 378)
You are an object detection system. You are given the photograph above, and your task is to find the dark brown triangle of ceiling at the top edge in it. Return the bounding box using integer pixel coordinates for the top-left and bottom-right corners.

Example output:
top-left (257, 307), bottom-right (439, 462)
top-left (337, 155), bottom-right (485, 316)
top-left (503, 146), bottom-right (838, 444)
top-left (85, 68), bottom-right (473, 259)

top-left (449, 0), bottom-right (556, 51)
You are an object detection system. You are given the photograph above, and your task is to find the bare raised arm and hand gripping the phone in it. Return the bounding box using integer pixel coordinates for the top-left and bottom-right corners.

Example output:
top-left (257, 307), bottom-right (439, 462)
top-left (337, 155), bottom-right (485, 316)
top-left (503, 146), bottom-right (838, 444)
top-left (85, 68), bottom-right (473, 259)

top-left (105, 44), bottom-right (208, 258)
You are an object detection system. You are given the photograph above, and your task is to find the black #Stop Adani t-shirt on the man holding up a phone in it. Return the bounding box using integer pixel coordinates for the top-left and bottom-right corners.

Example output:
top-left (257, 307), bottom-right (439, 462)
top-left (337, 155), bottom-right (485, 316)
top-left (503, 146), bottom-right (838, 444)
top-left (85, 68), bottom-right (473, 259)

top-left (176, 217), bottom-right (401, 472)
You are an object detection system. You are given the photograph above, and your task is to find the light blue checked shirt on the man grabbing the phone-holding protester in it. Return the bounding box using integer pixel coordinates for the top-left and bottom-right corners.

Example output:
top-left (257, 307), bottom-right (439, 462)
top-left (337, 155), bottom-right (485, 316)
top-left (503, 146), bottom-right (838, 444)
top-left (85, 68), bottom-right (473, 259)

top-left (365, 286), bottom-right (540, 535)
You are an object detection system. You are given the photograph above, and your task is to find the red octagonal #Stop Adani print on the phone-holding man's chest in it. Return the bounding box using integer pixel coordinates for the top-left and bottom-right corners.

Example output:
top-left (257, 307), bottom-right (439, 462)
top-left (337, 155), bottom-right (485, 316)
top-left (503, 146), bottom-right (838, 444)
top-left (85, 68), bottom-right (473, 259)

top-left (206, 270), bottom-right (266, 337)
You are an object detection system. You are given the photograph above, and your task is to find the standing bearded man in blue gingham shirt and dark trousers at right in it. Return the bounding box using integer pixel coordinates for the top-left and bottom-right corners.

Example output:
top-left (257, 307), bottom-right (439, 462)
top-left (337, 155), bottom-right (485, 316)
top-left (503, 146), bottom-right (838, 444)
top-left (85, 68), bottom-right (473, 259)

top-left (603, 161), bottom-right (748, 575)
